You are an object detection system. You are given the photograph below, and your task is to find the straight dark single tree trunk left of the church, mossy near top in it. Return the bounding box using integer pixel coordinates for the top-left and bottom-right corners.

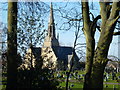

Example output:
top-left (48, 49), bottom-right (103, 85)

top-left (6, 0), bottom-right (17, 90)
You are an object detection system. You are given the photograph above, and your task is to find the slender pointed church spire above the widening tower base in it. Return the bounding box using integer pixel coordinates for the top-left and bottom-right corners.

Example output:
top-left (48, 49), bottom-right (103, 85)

top-left (48, 2), bottom-right (55, 38)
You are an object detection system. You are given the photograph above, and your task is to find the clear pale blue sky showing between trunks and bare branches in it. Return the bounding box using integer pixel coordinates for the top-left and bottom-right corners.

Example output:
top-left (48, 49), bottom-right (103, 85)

top-left (0, 2), bottom-right (118, 57)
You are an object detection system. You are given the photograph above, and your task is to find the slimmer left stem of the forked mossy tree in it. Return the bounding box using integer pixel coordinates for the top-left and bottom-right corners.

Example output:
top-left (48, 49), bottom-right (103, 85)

top-left (82, 0), bottom-right (95, 90)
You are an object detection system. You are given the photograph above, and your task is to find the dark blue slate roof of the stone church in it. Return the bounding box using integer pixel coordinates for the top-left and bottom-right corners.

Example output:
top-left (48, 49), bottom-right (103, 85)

top-left (32, 46), bottom-right (79, 63)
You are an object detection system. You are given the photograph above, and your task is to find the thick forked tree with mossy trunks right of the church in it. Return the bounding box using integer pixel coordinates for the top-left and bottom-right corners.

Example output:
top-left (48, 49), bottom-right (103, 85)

top-left (82, 0), bottom-right (120, 90)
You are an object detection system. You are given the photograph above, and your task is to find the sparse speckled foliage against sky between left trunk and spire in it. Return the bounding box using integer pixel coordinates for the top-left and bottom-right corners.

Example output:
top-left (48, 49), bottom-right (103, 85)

top-left (17, 2), bottom-right (48, 55)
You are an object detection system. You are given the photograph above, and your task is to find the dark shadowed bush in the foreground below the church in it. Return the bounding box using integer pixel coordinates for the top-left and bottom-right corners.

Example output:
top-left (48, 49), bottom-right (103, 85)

top-left (18, 68), bottom-right (59, 90)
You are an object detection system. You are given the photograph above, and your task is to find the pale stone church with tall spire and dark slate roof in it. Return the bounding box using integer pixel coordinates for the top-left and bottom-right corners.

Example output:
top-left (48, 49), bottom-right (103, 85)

top-left (25, 3), bottom-right (79, 70)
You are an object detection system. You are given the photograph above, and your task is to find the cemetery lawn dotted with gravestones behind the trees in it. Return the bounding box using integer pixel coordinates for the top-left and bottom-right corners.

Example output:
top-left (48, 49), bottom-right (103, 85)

top-left (54, 71), bottom-right (120, 89)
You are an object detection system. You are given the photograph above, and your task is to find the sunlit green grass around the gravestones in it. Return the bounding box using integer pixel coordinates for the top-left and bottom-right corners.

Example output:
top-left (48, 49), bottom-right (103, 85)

top-left (0, 71), bottom-right (120, 90)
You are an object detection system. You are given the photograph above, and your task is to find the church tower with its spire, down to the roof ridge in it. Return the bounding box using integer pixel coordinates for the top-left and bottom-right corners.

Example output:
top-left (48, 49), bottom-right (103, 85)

top-left (43, 3), bottom-right (59, 47)
